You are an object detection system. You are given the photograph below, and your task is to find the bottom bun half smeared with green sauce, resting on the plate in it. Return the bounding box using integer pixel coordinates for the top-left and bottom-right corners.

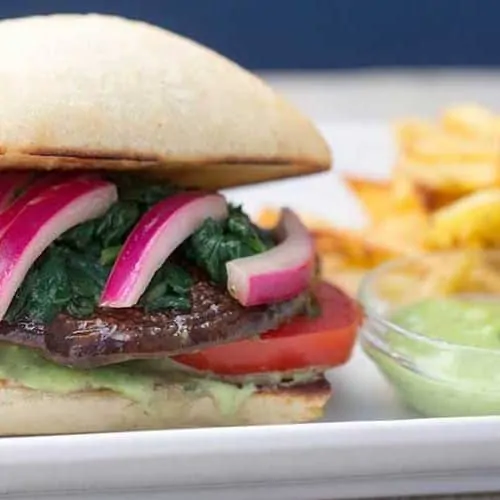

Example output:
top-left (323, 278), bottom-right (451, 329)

top-left (0, 380), bottom-right (331, 436)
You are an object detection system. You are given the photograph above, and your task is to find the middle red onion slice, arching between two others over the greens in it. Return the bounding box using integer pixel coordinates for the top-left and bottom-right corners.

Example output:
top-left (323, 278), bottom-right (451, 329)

top-left (100, 192), bottom-right (228, 308)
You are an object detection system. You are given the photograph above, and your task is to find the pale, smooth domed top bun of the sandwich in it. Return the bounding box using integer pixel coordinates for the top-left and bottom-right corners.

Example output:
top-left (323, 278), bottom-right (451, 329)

top-left (0, 14), bottom-right (331, 188)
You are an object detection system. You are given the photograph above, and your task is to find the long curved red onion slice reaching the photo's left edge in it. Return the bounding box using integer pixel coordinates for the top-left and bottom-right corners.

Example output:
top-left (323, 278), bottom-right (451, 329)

top-left (0, 179), bottom-right (117, 320)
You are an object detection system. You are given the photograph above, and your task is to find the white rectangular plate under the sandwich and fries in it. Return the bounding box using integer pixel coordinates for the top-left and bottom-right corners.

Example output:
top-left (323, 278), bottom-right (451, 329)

top-left (0, 124), bottom-right (500, 500)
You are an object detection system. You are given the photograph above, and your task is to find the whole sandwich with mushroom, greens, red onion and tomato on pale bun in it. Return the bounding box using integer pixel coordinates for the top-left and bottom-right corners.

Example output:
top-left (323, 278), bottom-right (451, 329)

top-left (0, 14), bottom-right (360, 436)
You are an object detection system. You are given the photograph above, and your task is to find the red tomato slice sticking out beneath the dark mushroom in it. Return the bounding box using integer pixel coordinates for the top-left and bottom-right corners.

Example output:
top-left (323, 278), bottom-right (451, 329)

top-left (173, 282), bottom-right (361, 375)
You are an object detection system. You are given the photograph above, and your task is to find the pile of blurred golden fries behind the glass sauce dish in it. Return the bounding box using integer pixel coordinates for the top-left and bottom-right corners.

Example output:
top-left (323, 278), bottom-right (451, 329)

top-left (258, 104), bottom-right (500, 294)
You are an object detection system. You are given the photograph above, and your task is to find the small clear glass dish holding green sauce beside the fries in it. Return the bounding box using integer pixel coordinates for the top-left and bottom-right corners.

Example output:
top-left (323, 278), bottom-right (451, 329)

top-left (358, 250), bottom-right (500, 417)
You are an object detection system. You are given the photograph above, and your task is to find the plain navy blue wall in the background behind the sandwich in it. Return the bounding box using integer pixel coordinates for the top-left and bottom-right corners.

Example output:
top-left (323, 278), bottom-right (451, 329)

top-left (0, 0), bottom-right (500, 69)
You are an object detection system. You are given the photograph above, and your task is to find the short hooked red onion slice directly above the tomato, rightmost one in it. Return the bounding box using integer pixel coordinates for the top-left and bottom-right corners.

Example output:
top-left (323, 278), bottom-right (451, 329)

top-left (226, 209), bottom-right (314, 306)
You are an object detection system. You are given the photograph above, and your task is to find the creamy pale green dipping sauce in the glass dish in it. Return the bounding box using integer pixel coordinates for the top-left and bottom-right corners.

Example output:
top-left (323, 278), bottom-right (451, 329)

top-left (364, 297), bottom-right (500, 417)
